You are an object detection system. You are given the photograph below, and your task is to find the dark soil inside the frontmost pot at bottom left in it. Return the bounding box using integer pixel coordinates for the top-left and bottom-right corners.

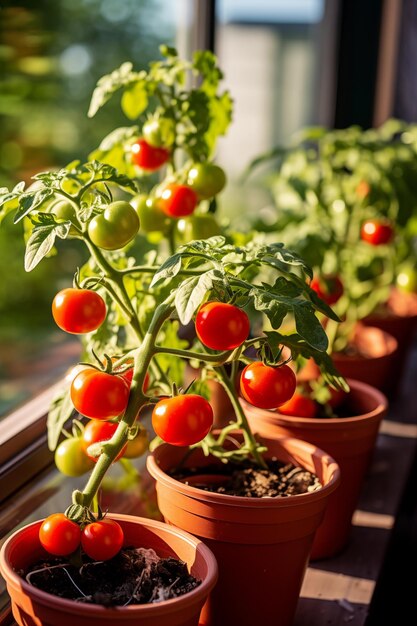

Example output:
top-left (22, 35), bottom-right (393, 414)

top-left (23, 548), bottom-right (201, 607)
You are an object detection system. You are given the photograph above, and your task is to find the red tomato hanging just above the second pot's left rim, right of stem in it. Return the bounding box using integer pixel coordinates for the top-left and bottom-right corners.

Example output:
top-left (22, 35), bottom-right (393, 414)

top-left (152, 394), bottom-right (213, 446)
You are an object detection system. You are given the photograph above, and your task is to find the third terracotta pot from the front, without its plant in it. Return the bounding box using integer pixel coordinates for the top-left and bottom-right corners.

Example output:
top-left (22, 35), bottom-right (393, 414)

top-left (241, 380), bottom-right (387, 559)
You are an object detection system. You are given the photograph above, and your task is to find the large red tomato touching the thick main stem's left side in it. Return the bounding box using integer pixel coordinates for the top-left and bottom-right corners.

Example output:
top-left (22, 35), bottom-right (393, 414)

top-left (71, 368), bottom-right (129, 420)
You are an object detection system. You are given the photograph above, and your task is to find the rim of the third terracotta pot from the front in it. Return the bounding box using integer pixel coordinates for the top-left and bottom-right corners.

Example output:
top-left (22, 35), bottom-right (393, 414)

top-left (239, 378), bottom-right (388, 429)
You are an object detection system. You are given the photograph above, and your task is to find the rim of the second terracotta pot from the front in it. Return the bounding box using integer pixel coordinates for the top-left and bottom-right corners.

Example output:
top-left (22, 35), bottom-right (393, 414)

top-left (146, 437), bottom-right (340, 509)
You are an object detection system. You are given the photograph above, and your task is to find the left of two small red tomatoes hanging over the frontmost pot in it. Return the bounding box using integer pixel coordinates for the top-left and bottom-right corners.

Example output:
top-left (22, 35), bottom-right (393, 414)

top-left (39, 513), bottom-right (81, 556)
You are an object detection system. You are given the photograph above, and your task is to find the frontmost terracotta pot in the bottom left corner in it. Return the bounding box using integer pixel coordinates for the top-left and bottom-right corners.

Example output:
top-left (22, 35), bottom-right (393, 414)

top-left (0, 515), bottom-right (217, 626)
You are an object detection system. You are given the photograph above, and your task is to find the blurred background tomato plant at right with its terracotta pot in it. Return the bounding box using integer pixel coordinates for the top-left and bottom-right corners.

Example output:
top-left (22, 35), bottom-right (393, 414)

top-left (245, 122), bottom-right (416, 388)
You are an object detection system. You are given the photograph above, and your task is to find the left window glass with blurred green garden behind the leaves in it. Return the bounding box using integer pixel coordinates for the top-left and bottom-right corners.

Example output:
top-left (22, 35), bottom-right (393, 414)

top-left (0, 0), bottom-right (177, 415)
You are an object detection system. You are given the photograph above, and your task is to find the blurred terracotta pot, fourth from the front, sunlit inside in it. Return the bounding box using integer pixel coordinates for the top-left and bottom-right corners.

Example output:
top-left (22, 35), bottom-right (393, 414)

top-left (332, 324), bottom-right (397, 391)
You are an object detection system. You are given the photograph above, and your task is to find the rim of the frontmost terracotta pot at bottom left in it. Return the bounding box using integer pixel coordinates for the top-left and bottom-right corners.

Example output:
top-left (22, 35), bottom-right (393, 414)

top-left (0, 514), bottom-right (218, 621)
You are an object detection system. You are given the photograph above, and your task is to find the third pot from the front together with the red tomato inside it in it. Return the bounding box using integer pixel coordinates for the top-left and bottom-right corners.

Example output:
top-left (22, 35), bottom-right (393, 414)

top-left (241, 372), bottom-right (388, 559)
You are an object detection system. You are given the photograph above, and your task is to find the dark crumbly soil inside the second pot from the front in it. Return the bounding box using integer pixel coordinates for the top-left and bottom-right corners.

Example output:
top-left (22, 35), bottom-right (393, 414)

top-left (173, 459), bottom-right (322, 498)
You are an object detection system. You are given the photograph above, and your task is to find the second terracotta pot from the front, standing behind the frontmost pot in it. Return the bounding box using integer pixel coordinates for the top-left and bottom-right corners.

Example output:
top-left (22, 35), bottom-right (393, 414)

top-left (148, 435), bottom-right (339, 626)
